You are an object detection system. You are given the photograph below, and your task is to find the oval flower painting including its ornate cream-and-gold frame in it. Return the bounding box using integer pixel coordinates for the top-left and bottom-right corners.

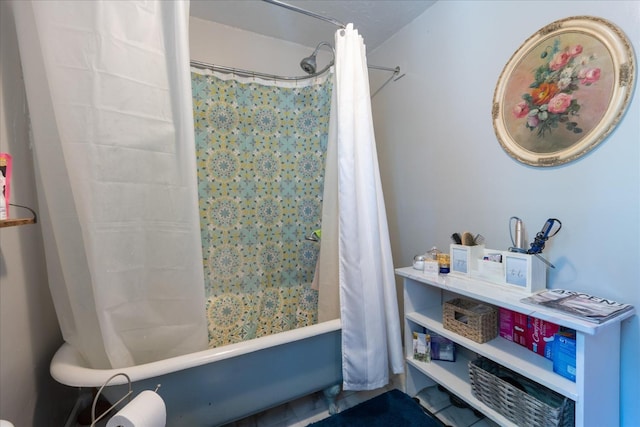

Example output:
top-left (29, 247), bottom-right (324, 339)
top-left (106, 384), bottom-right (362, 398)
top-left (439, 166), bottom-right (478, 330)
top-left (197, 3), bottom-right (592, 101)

top-left (492, 16), bottom-right (635, 166)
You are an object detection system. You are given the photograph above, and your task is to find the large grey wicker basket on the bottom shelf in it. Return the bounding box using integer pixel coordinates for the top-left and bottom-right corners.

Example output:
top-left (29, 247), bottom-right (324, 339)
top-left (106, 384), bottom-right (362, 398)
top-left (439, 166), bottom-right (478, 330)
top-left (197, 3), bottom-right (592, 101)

top-left (469, 357), bottom-right (575, 427)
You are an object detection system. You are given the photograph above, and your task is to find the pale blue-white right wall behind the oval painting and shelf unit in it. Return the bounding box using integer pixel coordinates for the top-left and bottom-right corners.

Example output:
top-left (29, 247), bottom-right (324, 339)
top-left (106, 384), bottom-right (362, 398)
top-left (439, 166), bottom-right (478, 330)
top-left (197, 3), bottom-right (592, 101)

top-left (369, 0), bottom-right (640, 427)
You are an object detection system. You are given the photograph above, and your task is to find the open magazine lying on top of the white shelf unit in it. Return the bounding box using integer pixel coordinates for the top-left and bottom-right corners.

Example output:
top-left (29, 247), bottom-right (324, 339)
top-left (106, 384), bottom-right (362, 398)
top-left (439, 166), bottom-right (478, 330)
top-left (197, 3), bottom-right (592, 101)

top-left (521, 289), bottom-right (633, 323)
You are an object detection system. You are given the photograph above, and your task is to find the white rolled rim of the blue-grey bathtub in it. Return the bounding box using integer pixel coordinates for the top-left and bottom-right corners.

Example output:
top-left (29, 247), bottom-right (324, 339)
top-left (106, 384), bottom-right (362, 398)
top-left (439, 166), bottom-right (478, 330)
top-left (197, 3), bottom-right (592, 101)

top-left (49, 319), bottom-right (341, 387)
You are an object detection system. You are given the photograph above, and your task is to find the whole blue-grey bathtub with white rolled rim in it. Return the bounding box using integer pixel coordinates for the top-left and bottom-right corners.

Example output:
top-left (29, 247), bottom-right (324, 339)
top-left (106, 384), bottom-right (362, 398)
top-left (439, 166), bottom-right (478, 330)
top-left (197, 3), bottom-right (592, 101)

top-left (50, 319), bottom-right (342, 427)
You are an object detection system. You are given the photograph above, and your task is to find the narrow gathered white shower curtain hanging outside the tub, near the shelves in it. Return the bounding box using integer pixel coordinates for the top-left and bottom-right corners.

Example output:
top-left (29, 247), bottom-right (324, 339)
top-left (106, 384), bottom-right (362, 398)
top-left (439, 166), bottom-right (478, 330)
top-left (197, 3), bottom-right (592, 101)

top-left (330, 24), bottom-right (404, 390)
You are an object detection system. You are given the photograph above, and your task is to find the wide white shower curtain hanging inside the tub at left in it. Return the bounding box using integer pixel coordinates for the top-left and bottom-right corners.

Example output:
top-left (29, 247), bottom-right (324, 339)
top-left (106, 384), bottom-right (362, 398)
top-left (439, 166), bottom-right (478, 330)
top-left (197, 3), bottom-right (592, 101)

top-left (12, 0), bottom-right (207, 368)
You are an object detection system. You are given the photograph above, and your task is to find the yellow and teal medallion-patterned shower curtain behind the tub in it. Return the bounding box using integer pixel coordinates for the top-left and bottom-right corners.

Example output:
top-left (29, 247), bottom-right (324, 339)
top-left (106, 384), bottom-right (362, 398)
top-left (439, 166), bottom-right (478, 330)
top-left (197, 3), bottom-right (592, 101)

top-left (192, 69), bottom-right (332, 347)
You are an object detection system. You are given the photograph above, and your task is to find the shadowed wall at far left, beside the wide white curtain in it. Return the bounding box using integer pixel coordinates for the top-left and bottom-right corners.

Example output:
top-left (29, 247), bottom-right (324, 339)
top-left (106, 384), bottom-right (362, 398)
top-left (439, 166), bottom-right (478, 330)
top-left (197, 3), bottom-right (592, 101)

top-left (0, 1), bottom-right (76, 427)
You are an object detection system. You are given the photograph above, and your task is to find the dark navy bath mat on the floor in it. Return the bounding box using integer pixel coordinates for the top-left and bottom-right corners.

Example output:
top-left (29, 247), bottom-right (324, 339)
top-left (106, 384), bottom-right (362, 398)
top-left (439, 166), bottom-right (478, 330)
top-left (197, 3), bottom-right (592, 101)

top-left (310, 390), bottom-right (444, 427)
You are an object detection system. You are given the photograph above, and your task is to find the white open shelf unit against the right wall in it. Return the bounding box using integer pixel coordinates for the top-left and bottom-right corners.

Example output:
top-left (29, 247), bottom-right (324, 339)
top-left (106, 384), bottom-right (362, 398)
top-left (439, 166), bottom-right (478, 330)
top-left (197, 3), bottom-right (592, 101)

top-left (396, 267), bottom-right (635, 427)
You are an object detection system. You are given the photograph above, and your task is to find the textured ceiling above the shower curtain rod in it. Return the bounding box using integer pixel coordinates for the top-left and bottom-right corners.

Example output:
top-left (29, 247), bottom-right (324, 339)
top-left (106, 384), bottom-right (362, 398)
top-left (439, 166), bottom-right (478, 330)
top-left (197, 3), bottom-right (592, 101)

top-left (191, 0), bottom-right (436, 50)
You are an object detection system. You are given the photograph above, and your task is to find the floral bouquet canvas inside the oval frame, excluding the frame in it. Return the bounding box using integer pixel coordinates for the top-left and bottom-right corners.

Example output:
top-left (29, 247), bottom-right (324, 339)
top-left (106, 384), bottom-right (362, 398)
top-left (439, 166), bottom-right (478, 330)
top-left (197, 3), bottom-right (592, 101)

top-left (504, 33), bottom-right (614, 153)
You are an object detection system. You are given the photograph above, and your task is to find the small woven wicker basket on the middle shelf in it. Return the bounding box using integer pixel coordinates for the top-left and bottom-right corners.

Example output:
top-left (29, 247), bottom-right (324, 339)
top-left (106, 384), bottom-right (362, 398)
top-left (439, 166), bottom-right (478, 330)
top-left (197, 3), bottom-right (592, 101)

top-left (442, 298), bottom-right (498, 344)
